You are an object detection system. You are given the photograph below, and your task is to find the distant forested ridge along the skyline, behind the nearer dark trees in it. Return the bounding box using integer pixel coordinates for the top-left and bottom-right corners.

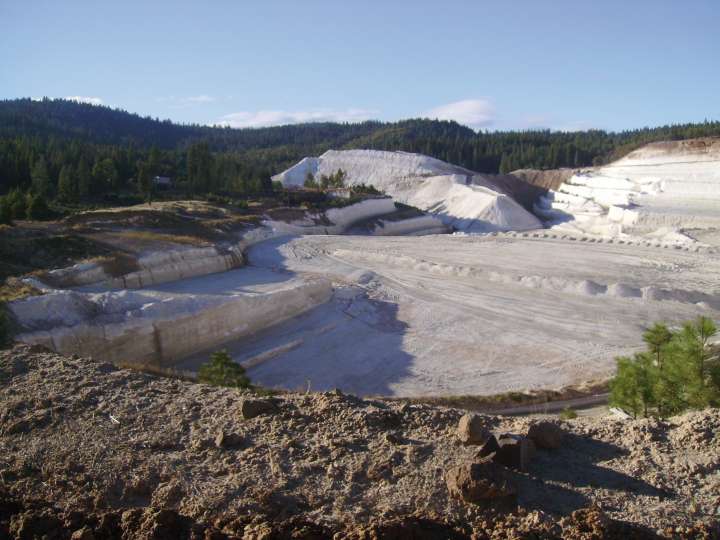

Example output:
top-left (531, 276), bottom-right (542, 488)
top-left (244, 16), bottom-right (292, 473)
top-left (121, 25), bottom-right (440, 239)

top-left (0, 99), bottom-right (720, 173)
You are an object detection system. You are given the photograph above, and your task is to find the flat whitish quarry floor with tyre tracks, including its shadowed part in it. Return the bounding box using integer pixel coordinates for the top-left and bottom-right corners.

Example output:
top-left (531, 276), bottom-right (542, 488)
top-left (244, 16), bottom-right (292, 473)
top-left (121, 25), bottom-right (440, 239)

top-left (176, 233), bottom-right (720, 397)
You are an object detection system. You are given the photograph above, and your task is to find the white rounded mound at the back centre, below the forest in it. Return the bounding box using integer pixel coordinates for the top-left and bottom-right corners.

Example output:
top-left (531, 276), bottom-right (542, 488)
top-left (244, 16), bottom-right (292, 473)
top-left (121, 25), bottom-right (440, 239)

top-left (273, 150), bottom-right (542, 232)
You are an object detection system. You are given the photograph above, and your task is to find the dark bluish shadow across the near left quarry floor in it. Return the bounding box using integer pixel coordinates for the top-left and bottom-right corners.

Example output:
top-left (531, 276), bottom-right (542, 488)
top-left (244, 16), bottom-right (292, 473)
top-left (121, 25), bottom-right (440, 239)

top-left (178, 288), bottom-right (413, 396)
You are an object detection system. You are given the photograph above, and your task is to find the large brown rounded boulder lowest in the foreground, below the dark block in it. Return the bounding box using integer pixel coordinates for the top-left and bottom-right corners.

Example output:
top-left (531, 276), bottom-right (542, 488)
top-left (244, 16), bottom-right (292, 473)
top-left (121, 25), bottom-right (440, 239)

top-left (445, 458), bottom-right (517, 503)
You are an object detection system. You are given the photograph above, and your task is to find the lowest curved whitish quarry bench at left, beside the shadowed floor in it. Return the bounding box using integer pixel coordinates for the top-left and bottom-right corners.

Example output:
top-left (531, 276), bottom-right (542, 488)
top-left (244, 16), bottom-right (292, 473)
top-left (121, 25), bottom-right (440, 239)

top-left (10, 279), bottom-right (332, 366)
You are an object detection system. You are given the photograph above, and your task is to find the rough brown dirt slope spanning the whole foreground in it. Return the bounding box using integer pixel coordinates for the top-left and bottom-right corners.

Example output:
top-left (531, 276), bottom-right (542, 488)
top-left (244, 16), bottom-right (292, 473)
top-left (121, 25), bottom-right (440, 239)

top-left (0, 345), bottom-right (720, 539)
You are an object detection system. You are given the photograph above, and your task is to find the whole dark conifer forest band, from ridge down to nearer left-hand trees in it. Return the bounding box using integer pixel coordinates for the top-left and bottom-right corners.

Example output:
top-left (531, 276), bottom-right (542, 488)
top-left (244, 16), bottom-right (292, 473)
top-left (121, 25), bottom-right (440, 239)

top-left (0, 99), bottom-right (720, 212)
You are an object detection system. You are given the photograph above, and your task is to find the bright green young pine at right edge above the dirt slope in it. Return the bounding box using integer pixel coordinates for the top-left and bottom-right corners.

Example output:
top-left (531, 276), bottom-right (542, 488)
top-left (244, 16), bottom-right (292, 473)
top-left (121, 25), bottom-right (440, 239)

top-left (610, 317), bottom-right (720, 418)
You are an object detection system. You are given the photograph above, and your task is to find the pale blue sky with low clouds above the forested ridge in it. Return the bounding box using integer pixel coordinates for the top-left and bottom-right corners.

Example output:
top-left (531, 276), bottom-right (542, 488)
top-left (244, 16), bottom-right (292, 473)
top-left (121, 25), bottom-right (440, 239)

top-left (0, 0), bottom-right (720, 130)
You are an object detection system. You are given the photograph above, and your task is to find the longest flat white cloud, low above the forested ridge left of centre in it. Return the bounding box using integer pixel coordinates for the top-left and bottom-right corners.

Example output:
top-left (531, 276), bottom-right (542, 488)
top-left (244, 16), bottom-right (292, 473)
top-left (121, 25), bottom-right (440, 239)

top-left (216, 109), bottom-right (378, 128)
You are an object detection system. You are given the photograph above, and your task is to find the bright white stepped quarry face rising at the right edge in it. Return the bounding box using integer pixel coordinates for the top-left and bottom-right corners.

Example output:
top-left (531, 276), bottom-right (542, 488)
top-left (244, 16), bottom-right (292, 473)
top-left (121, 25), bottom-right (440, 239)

top-left (536, 139), bottom-right (720, 242)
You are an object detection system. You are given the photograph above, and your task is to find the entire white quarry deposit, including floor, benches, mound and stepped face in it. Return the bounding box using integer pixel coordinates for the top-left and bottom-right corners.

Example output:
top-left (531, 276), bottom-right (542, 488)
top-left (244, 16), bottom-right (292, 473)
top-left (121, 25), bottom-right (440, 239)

top-left (10, 140), bottom-right (720, 397)
